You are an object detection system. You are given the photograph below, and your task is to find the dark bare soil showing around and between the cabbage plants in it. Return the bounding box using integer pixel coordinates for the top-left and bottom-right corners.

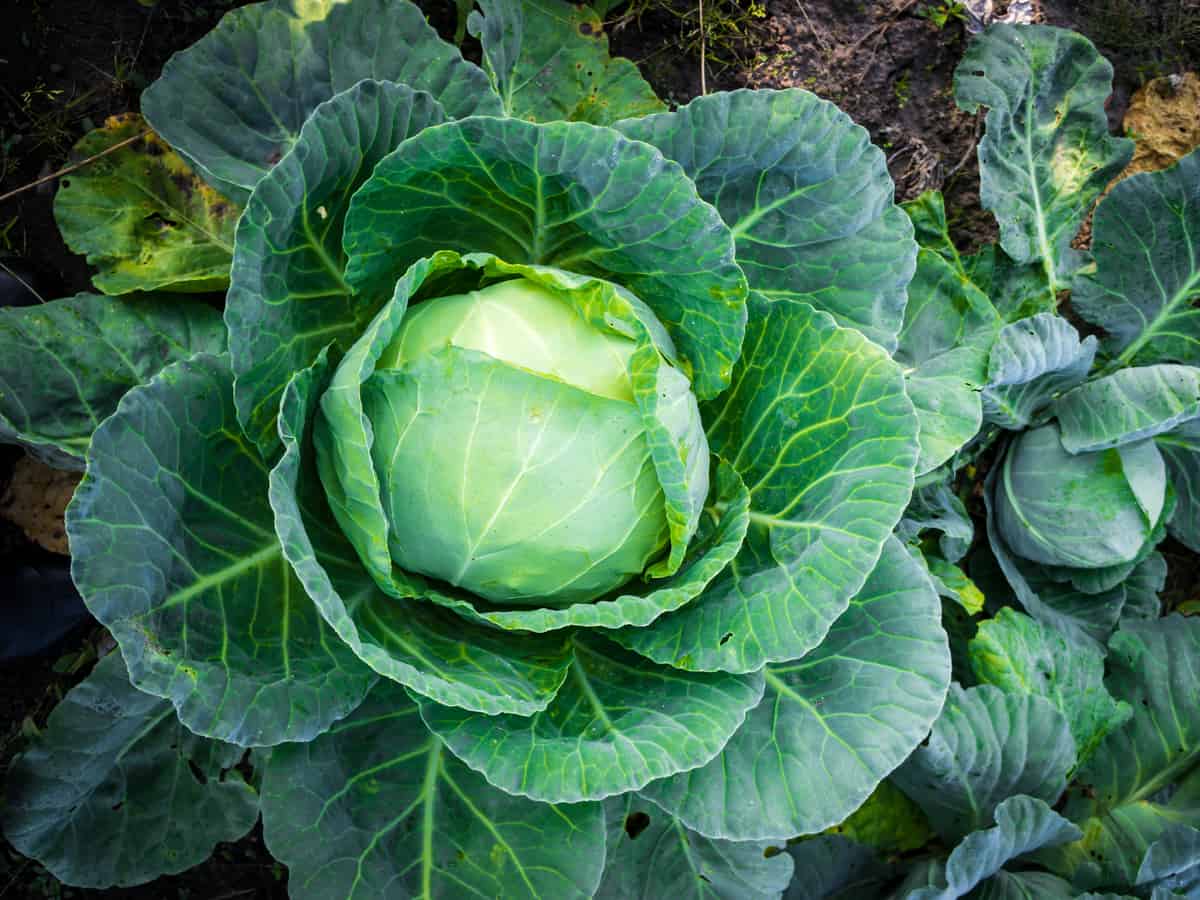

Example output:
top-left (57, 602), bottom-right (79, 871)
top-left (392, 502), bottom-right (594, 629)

top-left (0, 0), bottom-right (1200, 900)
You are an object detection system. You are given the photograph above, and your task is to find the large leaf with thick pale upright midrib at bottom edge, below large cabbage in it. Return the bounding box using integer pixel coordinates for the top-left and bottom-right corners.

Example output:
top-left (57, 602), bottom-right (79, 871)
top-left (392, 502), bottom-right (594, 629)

top-left (263, 682), bottom-right (605, 900)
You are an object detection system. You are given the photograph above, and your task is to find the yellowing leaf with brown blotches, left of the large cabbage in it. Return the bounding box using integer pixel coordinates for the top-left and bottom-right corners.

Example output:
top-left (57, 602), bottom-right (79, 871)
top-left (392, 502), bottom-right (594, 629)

top-left (54, 113), bottom-right (241, 294)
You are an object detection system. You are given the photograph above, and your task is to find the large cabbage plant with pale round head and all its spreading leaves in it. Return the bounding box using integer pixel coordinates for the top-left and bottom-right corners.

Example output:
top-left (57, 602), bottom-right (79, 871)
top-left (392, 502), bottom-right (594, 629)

top-left (0, 0), bottom-right (949, 900)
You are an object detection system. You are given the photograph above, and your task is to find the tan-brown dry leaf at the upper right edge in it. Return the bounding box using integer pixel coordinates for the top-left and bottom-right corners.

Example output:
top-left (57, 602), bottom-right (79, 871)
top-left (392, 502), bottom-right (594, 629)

top-left (1122, 72), bottom-right (1200, 178)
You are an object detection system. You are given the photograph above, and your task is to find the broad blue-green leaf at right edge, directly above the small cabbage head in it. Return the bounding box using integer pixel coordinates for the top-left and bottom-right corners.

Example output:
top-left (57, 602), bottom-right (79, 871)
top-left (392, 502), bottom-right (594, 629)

top-left (1070, 152), bottom-right (1200, 366)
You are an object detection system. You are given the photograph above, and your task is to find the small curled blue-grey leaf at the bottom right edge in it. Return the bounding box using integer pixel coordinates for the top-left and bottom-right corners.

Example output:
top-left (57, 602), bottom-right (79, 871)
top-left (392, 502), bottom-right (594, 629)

top-left (904, 796), bottom-right (1082, 900)
